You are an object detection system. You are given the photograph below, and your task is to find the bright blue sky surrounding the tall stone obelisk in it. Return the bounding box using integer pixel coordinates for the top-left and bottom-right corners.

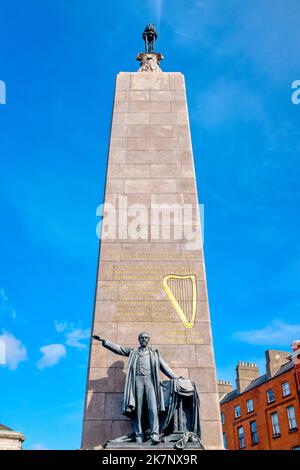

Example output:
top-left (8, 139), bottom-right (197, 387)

top-left (0, 0), bottom-right (300, 449)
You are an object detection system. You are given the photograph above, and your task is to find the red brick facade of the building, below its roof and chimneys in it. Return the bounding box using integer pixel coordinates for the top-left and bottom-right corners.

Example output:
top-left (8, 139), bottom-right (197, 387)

top-left (221, 362), bottom-right (300, 450)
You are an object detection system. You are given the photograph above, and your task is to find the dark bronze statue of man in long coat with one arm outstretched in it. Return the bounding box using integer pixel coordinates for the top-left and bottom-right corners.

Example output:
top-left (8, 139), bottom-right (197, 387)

top-left (93, 332), bottom-right (178, 444)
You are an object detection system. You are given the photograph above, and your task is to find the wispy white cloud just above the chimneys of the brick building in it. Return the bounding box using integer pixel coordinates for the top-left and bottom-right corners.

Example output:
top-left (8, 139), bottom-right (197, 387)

top-left (233, 320), bottom-right (300, 349)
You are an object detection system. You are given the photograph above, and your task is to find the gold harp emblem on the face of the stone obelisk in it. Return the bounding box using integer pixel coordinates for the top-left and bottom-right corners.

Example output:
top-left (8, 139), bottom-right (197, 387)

top-left (163, 274), bottom-right (197, 328)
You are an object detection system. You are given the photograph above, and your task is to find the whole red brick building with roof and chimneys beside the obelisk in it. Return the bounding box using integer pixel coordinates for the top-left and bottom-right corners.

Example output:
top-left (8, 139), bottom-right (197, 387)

top-left (218, 341), bottom-right (300, 450)
